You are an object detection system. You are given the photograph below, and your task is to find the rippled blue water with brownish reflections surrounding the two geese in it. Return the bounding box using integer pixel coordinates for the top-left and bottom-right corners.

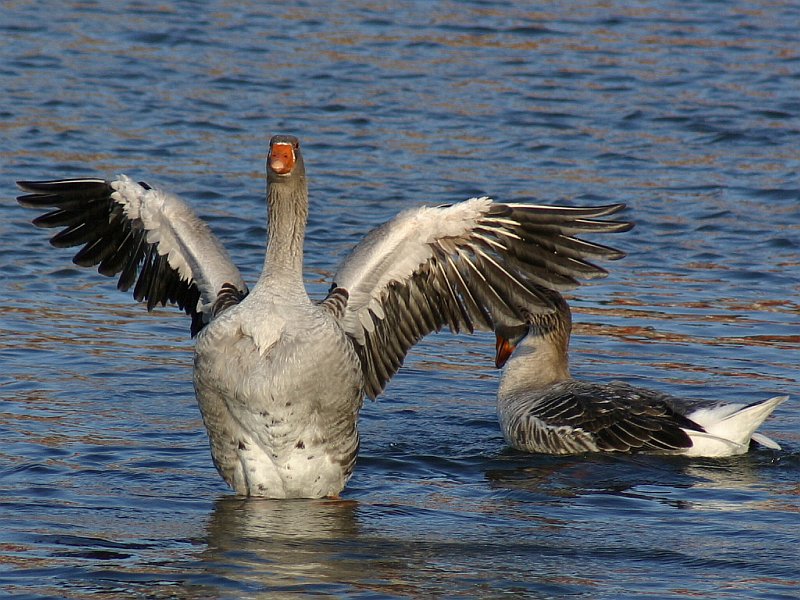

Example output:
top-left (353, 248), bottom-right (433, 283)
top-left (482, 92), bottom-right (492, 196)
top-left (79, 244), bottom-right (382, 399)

top-left (0, 0), bottom-right (800, 598)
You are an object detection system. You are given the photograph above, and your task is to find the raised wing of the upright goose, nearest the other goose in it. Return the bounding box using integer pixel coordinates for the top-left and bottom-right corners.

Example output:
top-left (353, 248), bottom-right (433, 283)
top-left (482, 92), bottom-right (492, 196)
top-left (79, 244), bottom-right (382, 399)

top-left (334, 197), bottom-right (632, 398)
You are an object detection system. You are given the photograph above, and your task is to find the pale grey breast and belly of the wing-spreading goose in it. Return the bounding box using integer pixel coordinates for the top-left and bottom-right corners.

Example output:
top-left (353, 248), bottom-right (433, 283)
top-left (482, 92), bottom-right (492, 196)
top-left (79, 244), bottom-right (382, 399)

top-left (194, 287), bottom-right (363, 497)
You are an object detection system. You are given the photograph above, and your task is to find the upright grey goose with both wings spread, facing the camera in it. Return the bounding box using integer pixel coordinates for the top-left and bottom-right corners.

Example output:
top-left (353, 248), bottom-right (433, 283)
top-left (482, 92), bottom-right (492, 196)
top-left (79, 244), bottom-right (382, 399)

top-left (18, 136), bottom-right (630, 498)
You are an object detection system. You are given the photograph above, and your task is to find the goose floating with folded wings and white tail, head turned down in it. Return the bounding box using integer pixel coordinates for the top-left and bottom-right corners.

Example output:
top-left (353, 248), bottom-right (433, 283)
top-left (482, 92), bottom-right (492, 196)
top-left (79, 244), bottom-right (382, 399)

top-left (496, 291), bottom-right (788, 457)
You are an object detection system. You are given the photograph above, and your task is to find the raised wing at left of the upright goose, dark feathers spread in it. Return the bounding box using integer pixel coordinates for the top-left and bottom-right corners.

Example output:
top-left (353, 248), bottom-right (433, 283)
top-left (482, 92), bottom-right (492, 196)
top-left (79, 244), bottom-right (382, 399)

top-left (17, 175), bottom-right (247, 335)
